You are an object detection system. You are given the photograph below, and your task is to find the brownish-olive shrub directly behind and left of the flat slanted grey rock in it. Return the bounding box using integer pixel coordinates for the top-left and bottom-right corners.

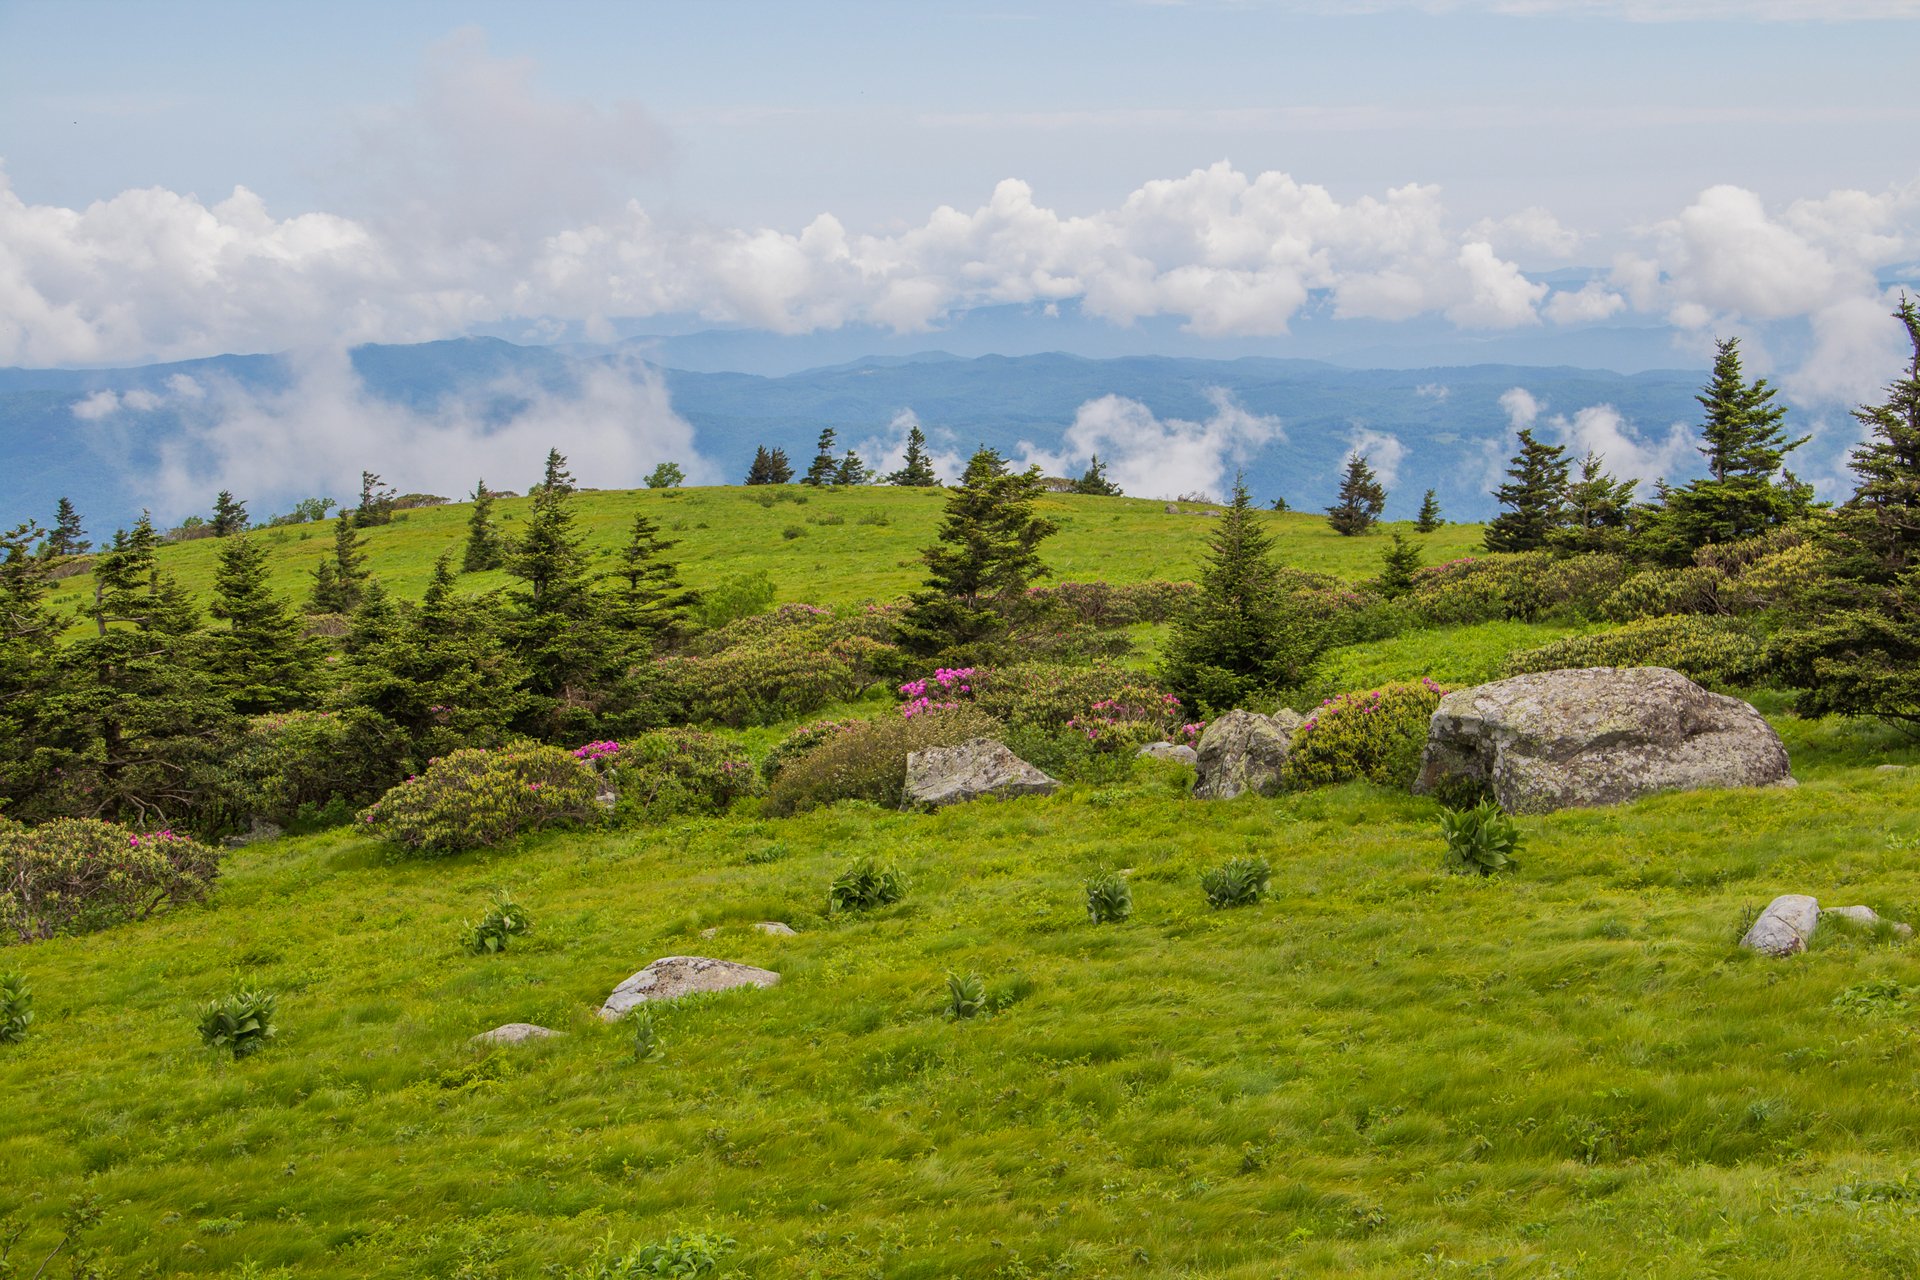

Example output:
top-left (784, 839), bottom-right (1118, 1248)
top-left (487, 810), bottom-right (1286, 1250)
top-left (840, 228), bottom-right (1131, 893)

top-left (766, 706), bottom-right (1002, 816)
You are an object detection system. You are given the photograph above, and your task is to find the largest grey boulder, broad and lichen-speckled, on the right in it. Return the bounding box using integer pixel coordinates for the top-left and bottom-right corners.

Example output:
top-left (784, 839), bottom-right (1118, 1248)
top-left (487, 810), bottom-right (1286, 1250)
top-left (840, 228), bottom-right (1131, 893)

top-left (1405, 666), bottom-right (1793, 814)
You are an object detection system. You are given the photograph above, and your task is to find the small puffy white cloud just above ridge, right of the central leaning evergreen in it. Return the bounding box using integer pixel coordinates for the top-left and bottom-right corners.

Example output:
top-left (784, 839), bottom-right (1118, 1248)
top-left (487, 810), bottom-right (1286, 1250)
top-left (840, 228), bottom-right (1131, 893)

top-left (1020, 388), bottom-right (1286, 497)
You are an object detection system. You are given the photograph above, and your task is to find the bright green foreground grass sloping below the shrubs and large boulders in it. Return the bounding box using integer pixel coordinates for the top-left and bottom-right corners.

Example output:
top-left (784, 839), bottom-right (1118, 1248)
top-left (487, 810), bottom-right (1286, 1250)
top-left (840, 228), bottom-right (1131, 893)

top-left (11, 706), bottom-right (1920, 1278)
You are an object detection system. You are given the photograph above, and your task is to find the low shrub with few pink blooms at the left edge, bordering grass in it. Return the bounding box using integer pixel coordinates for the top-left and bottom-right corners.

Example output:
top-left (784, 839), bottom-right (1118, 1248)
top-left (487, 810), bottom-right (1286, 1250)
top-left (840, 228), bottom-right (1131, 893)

top-left (0, 818), bottom-right (221, 942)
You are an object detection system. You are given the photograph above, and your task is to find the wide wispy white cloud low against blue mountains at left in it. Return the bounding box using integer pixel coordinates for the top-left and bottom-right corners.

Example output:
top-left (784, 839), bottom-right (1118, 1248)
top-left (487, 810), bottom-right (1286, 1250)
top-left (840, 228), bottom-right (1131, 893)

top-left (73, 347), bottom-right (718, 518)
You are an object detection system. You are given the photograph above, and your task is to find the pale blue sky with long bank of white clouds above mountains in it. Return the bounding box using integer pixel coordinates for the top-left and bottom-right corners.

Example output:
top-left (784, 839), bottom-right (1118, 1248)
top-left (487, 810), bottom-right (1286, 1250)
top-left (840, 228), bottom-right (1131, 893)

top-left (0, 0), bottom-right (1920, 401)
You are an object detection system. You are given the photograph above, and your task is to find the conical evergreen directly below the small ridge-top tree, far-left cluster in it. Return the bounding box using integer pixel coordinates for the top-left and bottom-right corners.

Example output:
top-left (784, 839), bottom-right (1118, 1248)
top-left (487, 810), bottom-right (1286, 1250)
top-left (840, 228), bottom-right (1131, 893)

top-left (207, 535), bottom-right (321, 716)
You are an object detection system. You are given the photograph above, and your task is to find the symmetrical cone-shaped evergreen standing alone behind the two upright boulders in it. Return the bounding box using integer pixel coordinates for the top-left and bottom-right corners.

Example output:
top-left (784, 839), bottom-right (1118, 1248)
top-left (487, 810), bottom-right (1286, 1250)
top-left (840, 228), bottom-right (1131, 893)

top-left (1160, 476), bottom-right (1321, 718)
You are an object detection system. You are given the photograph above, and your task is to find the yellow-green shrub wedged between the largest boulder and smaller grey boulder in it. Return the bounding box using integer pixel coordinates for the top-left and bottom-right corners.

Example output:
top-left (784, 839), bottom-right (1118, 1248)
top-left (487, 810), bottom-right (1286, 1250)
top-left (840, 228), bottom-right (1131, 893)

top-left (1283, 679), bottom-right (1446, 787)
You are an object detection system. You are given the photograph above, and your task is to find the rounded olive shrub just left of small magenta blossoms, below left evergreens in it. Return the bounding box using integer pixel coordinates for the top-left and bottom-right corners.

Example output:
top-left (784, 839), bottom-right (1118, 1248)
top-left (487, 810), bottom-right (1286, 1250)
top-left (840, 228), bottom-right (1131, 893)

top-left (359, 745), bottom-right (599, 854)
